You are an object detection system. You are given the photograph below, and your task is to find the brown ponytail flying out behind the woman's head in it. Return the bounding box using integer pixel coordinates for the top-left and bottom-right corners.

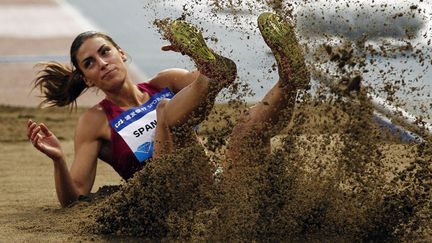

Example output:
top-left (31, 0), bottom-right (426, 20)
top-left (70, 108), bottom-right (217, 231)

top-left (34, 62), bottom-right (88, 109)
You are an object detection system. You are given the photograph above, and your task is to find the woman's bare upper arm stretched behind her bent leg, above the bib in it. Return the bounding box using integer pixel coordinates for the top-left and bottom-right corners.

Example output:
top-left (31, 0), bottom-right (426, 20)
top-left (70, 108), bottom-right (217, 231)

top-left (149, 68), bottom-right (200, 93)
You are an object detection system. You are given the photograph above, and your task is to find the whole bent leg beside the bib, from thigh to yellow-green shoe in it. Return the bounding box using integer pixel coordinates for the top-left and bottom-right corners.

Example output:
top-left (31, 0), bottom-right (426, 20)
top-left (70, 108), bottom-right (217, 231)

top-left (154, 20), bottom-right (237, 157)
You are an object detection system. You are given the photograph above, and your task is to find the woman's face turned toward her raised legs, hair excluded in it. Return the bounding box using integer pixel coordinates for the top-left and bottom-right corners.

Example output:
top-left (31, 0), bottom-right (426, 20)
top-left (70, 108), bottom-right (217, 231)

top-left (76, 37), bottom-right (127, 91)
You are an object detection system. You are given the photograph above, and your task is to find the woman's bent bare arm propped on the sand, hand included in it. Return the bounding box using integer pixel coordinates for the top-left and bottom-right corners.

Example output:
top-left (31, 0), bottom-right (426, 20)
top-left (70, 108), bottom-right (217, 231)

top-left (27, 108), bottom-right (106, 207)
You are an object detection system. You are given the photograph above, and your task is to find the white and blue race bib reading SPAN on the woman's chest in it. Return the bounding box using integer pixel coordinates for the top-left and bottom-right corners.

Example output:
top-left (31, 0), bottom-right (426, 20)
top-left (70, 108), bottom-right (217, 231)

top-left (111, 88), bottom-right (174, 162)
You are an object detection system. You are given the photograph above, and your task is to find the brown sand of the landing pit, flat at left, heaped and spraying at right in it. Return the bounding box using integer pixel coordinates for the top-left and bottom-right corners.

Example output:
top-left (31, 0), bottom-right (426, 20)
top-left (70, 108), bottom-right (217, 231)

top-left (0, 95), bottom-right (431, 242)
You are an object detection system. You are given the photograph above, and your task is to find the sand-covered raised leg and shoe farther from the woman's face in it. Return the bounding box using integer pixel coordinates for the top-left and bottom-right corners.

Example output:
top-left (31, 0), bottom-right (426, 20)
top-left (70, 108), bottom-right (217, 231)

top-left (225, 13), bottom-right (310, 166)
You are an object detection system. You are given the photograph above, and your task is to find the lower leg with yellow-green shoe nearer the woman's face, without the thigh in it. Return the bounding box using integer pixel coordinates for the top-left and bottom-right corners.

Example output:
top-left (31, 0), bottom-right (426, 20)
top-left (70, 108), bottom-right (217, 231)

top-left (159, 20), bottom-right (237, 127)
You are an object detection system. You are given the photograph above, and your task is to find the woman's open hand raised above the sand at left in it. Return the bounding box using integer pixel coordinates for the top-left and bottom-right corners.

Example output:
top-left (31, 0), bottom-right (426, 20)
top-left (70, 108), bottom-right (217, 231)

top-left (27, 120), bottom-right (64, 161)
